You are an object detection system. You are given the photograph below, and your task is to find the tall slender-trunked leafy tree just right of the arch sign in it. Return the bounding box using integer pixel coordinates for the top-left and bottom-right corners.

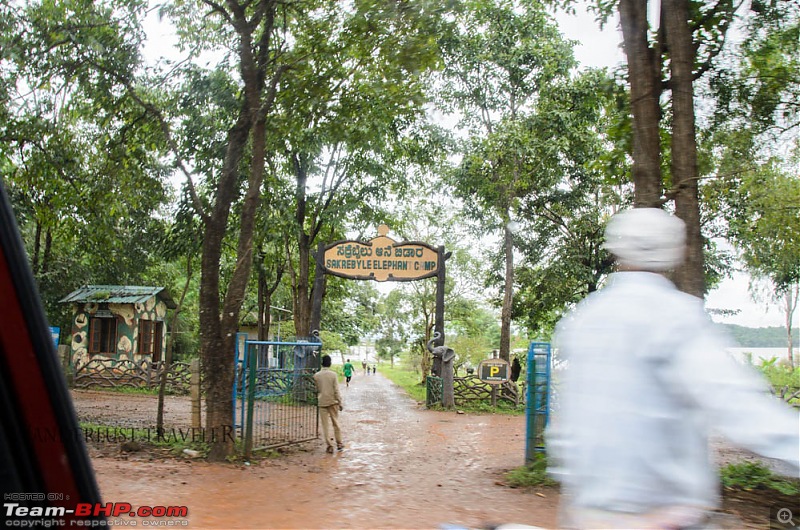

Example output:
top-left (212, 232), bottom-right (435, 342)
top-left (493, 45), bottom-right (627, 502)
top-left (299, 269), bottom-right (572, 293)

top-left (441, 0), bottom-right (575, 360)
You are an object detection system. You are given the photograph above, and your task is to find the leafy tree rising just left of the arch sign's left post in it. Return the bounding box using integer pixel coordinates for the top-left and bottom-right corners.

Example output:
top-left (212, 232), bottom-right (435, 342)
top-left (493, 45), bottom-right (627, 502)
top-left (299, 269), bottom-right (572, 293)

top-left (270, 0), bottom-right (443, 336)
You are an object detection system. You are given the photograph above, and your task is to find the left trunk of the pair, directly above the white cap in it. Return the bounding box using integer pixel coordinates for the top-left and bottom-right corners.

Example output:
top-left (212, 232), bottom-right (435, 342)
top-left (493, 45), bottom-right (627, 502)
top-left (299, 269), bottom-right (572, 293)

top-left (619, 0), bottom-right (663, 208)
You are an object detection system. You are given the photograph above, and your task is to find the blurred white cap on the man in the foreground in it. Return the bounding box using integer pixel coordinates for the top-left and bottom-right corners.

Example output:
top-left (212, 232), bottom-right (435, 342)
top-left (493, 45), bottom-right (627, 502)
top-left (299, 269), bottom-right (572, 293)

top-left (604, 208), bottom-right (686, 271)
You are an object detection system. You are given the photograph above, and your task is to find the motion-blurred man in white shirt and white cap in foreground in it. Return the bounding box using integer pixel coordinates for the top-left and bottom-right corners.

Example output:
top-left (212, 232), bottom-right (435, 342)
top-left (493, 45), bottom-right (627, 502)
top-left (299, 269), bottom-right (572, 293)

top-left (547, 209), bottom-right (800, 528)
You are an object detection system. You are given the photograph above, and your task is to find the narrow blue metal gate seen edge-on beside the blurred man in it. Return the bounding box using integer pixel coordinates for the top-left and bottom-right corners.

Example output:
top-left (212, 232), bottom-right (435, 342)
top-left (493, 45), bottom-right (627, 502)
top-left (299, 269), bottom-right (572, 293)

top-left (525, 342), bottom-right (552, 462)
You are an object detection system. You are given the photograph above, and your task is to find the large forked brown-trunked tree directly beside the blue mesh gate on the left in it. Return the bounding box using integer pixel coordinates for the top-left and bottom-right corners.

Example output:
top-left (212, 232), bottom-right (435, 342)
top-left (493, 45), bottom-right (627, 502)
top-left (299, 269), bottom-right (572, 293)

top-left (162, 0), bottom-right (290, 460)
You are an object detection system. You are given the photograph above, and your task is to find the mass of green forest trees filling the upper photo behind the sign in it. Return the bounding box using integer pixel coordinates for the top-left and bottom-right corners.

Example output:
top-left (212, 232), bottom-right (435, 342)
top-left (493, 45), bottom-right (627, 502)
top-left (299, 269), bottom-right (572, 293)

top-left (0, 0), bottom-right (800, 456)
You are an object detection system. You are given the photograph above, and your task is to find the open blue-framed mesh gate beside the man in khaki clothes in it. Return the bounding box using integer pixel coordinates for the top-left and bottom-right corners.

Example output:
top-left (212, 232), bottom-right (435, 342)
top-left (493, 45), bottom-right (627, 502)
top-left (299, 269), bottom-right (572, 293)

top-left (233, 334), bottom-right (322, 458)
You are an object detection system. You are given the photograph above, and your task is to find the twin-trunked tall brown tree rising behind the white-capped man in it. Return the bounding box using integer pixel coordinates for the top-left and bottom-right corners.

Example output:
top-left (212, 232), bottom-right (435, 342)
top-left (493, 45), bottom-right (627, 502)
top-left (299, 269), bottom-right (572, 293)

top-left (556, 0), bottom-right (736, 297)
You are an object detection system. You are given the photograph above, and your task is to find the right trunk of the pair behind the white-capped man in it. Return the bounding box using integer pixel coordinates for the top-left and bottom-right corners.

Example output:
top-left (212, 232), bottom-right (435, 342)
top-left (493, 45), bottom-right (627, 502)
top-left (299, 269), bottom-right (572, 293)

top-left (663, 0), bottom-right (705, 298)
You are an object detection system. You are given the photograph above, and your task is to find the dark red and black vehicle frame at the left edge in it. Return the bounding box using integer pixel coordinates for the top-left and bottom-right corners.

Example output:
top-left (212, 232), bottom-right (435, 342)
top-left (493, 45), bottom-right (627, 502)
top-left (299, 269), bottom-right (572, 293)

top-left (0, 178), bottom-right (100, 513)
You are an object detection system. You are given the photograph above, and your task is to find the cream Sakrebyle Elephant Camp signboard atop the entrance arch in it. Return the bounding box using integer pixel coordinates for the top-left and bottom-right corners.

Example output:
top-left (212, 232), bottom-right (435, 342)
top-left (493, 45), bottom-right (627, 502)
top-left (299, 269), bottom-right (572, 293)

top-left (322, 225), bottom-right (439, 282)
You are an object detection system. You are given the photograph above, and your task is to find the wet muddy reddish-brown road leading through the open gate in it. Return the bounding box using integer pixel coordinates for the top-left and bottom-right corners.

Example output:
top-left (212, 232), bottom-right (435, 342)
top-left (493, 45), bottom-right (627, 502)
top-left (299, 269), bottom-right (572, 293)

top-left (73, 374), bottom-right (788, 529)
